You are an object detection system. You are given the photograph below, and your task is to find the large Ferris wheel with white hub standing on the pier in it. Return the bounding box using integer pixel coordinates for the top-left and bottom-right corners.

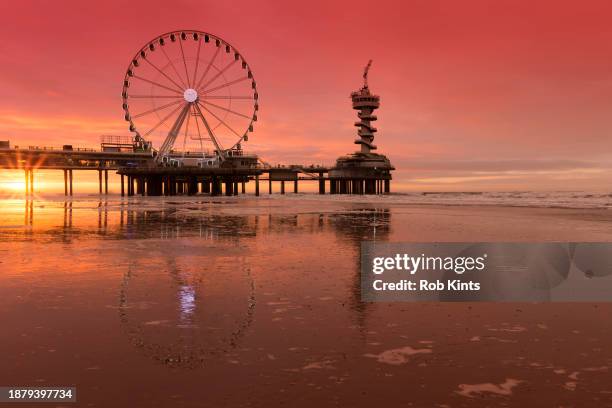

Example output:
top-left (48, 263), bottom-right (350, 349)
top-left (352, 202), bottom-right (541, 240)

top-left (122, 30), bottom-right (258, 159)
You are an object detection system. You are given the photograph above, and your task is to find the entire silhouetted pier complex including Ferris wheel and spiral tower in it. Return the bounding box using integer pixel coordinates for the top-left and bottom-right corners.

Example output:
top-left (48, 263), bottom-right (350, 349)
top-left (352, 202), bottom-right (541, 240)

top-left (0, 43), bottom-right (394, 196)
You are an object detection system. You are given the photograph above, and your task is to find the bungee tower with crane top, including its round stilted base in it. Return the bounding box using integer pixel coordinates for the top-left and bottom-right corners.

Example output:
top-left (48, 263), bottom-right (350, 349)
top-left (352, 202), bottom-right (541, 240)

top-left (329, 60), bottom-right (395, 194)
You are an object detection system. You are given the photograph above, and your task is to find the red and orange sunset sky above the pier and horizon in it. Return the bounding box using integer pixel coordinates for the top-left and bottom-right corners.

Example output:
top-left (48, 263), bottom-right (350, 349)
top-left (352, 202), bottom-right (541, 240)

top-left (0, 0), bottom-right (612, 191)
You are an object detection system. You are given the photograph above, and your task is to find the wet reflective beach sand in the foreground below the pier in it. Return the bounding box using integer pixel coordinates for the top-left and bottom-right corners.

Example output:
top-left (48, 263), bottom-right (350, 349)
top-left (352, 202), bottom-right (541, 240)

top-left (0, 196), bottom-right (612, 407)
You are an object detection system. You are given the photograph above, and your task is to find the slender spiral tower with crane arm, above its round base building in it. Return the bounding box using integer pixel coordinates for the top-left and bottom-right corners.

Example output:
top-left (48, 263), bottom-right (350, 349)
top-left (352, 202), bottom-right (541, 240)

top-left (351, 60), bottom-right (380, 153)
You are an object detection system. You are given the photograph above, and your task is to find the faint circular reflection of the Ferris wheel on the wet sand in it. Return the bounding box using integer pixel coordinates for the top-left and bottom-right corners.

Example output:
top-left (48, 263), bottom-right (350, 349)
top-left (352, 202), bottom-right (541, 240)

top-left (119, 258), bottom-right (255, 368)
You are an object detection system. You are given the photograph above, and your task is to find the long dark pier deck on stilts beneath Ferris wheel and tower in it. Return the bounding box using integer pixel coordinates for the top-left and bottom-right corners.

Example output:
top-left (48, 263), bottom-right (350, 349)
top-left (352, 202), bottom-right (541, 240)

top-left (0, 146), bottom-right (390, 196)
